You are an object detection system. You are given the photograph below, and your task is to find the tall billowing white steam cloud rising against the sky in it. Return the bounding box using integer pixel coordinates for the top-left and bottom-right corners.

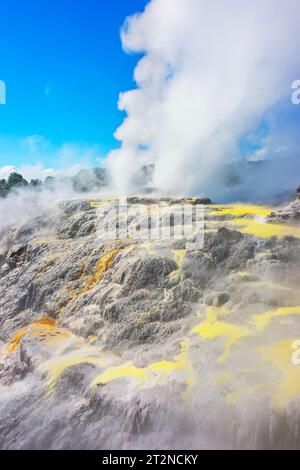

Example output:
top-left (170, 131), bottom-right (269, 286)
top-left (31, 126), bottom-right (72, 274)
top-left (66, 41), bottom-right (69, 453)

top-left (108, 0), bottom-right (300, 192)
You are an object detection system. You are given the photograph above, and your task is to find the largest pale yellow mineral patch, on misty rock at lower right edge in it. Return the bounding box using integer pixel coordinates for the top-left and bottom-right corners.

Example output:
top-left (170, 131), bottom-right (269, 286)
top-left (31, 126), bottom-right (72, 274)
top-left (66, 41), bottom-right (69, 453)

top-left (192, 307), bottom-right (300, 412)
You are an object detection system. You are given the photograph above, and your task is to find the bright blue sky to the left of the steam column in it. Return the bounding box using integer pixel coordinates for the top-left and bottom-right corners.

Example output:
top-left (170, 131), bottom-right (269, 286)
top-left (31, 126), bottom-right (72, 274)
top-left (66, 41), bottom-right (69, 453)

top-left (0, 0), bottom-right (147, 173)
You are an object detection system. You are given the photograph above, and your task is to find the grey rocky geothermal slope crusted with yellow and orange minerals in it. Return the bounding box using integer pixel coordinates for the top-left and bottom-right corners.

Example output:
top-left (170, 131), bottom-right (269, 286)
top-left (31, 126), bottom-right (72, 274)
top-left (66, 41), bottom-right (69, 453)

top-left (0, 194), bottom-right (300, 449)
